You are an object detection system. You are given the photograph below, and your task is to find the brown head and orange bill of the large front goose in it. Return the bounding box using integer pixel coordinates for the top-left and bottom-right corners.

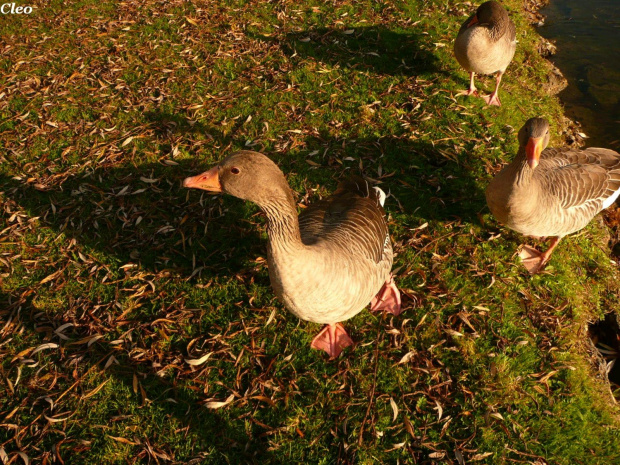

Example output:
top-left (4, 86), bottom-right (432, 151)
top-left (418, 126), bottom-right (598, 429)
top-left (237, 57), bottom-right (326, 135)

top-left (183, 150), bottom-right (292, 206)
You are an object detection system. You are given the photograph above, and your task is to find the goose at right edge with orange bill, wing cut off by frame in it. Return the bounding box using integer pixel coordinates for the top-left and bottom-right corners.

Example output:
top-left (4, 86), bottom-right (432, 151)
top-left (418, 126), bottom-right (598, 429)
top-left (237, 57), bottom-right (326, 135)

top-left (486, 118), bottom-right (620, 274)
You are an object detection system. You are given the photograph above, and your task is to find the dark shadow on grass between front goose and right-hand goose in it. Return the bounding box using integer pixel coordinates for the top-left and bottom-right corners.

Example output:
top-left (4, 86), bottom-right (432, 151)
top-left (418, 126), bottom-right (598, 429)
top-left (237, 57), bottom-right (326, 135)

top-left (294, 133), bottom-right (486, 222)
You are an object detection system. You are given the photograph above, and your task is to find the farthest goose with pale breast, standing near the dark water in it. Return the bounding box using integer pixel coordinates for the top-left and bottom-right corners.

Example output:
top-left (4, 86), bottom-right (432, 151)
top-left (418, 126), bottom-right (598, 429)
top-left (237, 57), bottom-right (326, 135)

top-left (454, 2), bottom-right (517, 106)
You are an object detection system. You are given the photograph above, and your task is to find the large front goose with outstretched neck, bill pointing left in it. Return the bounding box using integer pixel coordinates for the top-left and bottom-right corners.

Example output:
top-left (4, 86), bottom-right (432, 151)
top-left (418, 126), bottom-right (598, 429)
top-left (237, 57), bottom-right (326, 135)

top-left (183, 151), bottom-right (401, 358)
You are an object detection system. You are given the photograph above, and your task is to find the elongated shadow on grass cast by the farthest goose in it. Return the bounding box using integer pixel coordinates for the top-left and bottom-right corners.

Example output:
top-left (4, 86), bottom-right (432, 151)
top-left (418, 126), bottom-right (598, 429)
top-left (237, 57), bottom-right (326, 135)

top-left (248, 26), bottom-right (442, 76)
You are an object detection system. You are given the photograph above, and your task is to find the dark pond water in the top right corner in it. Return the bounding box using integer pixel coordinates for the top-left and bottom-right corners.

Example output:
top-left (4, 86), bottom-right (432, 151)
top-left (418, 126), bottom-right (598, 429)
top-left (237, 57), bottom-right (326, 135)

top-left (538, 0), bottom-right (620, 150)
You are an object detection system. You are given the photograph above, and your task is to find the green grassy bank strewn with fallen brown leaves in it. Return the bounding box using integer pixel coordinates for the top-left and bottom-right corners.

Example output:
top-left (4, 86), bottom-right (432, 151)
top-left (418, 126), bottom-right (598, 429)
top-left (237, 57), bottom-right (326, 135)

top-left (0, 0), bottom-right (620, 464)
